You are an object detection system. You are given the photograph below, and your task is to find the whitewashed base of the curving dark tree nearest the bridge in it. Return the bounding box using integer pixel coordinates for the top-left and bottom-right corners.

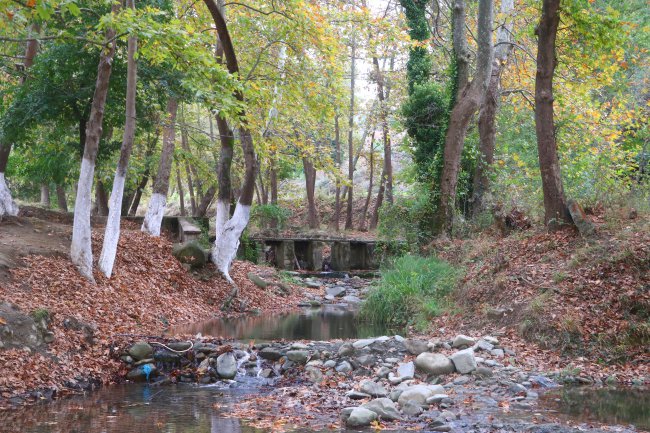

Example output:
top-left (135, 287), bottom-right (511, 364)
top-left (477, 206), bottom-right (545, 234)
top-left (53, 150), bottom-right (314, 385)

top-left (211, 202), bottom-right (251, 284)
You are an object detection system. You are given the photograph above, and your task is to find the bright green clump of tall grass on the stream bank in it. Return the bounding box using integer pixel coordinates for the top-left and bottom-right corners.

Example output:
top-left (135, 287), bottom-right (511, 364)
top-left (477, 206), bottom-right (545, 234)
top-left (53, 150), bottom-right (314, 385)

top-left (361, 254), bottom-right (460, 329)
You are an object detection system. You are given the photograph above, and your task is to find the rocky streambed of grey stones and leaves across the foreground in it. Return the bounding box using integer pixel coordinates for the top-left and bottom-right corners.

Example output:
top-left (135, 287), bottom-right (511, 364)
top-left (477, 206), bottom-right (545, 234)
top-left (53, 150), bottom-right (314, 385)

top-left (117, 335), bottom-right (636, 432)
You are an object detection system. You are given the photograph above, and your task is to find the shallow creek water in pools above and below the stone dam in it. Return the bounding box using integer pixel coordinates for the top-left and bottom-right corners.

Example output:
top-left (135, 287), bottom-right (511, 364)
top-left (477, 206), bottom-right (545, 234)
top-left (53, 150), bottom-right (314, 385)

top-left (0, 276), bottom-right (650, 433)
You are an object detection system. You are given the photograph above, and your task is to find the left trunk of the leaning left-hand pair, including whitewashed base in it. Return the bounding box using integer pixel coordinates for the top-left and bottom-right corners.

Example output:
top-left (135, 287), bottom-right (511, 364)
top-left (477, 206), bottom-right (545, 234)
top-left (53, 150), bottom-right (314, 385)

top-left (70, 9), bottom-right (119, 281)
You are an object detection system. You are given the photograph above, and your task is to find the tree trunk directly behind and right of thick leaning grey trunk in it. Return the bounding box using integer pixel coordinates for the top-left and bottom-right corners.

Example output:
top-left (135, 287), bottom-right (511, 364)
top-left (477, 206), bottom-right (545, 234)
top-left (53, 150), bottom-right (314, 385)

top-left (472, 0), bottom-right (514, 216)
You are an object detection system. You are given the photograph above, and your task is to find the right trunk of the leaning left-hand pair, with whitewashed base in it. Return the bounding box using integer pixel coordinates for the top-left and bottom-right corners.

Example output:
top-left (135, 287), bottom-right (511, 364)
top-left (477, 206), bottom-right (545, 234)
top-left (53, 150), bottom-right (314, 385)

top-left (98, 8), bottom-right (138, 278)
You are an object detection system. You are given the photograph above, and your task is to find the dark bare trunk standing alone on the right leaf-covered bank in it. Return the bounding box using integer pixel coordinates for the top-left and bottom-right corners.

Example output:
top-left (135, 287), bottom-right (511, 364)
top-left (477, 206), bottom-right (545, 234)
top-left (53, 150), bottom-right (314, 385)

top-left (535, 0), bottom-right (572, 230)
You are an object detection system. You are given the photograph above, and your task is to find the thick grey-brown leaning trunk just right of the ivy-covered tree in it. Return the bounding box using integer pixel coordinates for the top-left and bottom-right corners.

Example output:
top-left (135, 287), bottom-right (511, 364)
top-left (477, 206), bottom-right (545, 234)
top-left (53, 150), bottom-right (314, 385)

top-left (434, 0), bottom-right (494, 234)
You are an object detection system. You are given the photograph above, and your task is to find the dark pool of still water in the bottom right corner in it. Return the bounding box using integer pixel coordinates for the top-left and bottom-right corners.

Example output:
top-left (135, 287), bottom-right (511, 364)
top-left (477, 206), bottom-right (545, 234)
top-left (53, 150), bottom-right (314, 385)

top-left (543, 387), bottom-right (650, 429)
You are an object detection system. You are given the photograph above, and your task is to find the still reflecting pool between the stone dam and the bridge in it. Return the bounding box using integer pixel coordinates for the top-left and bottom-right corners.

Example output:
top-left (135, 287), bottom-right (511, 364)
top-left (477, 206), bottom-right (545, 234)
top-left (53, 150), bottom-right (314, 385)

top-left (170, 305), bottom-right (388, 340)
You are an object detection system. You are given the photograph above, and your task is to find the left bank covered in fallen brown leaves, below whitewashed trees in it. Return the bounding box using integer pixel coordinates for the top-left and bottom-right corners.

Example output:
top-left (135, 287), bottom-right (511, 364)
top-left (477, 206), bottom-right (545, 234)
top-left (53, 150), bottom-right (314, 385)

top-left (0, 213), bottom-right (302, 407)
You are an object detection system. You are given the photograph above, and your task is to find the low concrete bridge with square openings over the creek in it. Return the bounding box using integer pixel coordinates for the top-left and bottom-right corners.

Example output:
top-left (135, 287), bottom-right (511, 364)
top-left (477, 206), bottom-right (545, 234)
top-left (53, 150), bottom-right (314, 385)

top-left (251, 236), bottom-right (379, 271)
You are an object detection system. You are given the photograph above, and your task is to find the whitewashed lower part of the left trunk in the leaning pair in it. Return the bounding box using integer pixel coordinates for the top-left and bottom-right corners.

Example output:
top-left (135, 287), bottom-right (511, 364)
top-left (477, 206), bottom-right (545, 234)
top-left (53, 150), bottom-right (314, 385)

top-left (70, 158), bottom-right (95, 281)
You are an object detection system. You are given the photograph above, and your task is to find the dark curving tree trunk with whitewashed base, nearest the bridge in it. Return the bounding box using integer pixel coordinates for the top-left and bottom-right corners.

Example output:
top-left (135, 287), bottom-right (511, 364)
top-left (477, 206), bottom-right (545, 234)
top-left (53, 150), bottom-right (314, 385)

top-left (204, 0), bottom-right (257, 284)
